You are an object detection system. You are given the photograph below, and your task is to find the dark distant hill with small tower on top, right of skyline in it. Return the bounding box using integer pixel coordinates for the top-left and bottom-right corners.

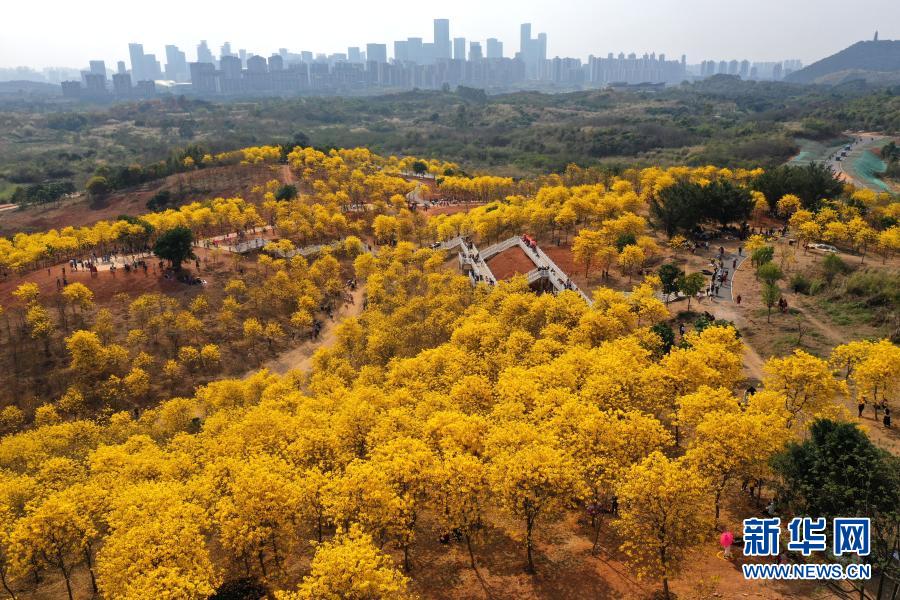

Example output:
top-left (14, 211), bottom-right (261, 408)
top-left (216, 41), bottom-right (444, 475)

top-left (786, 40), bottom-right (900, 84)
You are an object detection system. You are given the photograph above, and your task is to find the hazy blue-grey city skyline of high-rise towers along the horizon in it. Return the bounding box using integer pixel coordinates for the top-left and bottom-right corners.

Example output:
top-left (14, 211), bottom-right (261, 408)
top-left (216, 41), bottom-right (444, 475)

top-left (62, 19), bottom-right (800, 97)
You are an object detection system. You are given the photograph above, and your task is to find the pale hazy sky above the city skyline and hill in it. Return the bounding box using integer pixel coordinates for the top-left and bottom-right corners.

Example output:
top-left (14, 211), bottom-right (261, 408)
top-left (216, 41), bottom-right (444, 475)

top-left (0, 0), bottom-right (900, 68)
